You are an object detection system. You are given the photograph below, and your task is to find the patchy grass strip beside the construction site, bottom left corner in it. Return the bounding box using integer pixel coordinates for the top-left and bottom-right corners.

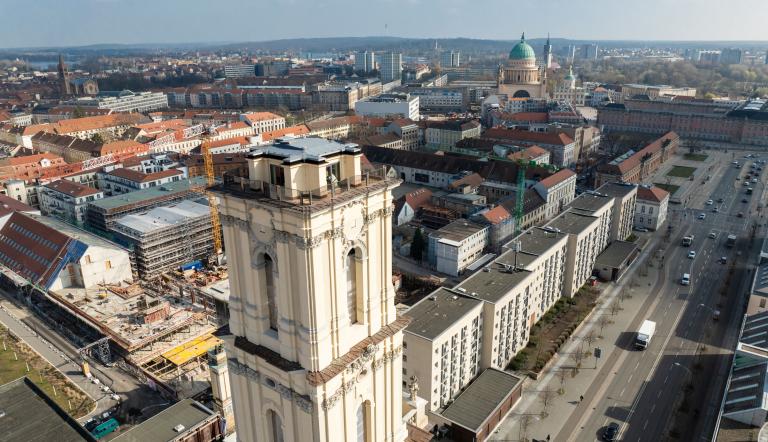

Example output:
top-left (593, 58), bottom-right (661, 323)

top-left (0, 326), bottom-right (94, 418)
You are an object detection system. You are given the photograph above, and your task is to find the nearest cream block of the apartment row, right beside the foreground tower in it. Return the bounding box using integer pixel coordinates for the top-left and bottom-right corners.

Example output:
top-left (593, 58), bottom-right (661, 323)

top-left (403, 288), bottom-right (484, 411)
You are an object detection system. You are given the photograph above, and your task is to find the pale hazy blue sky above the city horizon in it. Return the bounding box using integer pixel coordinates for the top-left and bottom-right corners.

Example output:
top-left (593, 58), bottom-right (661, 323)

top-left (0, 0), bottom-right (768, 47)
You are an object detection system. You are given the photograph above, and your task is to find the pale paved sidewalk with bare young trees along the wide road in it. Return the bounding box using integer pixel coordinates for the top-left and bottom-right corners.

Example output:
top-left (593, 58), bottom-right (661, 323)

top-left (490, 232), bottom-right (663, 441)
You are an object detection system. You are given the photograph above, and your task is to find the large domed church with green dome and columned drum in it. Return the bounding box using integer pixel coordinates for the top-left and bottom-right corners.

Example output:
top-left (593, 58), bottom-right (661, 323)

top-left (496, 33), bottom-right (547, 98)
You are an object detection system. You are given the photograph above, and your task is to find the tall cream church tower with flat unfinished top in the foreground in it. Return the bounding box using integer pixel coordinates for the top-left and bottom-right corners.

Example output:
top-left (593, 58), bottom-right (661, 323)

top-left (215, 138), bottom-right (408, 442)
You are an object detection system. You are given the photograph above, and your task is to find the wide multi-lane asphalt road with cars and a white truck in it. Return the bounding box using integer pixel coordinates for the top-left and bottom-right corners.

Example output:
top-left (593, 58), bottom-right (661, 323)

top-left (555, 154), bottom-right (763, 441)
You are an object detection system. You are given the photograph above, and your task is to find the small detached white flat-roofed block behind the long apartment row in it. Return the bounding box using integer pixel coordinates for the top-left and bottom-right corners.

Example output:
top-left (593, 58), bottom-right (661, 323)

top-left (428, 219), bottom-right (490, 276)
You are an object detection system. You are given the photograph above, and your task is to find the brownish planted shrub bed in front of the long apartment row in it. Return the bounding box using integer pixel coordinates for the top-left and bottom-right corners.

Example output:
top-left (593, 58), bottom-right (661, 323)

top-left (509, 286), bottom-right (600, 373)
